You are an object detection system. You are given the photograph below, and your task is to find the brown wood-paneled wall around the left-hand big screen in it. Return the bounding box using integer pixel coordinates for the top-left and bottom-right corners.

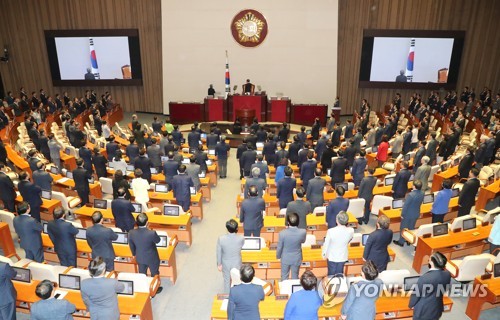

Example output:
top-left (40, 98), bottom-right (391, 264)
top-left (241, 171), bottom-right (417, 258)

top-left (0, 0), bottom-right (163, 113)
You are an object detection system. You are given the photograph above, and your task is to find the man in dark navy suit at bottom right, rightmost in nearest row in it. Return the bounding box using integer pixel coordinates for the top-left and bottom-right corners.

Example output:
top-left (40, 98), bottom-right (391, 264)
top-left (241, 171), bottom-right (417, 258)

top-left (408, 252), bottom-right (451, 320)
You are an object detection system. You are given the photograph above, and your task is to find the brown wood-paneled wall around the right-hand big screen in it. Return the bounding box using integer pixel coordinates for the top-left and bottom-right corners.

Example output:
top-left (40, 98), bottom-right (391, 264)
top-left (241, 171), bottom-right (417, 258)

top-left (337, 0), bottom-right (500, 114)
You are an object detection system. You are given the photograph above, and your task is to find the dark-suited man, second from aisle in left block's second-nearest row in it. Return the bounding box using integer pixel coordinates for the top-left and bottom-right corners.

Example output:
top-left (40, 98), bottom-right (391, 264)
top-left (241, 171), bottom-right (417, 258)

top-left (87, 211), bottom-right (118, 271)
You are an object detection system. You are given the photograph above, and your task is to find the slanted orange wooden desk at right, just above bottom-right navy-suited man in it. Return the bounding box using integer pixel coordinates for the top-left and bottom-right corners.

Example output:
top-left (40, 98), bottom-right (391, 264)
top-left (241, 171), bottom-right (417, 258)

top-left (413, 225), bottom-right (492, 273)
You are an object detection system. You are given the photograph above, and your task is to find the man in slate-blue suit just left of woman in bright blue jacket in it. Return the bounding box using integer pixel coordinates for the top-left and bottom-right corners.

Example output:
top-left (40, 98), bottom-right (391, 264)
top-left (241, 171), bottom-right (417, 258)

top-left (392, 180), bottom-right (424, 247)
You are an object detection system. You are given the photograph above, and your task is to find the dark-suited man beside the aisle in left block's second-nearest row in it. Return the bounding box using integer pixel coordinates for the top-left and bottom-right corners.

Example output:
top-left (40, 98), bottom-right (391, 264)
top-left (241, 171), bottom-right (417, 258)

top-left (128, 213), bottom-right (163, 293)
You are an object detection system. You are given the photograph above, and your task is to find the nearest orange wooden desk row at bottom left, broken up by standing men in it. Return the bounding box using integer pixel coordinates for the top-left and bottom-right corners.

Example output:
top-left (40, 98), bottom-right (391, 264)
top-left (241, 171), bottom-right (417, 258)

top-left (13, 280), bottom-right (153, 320)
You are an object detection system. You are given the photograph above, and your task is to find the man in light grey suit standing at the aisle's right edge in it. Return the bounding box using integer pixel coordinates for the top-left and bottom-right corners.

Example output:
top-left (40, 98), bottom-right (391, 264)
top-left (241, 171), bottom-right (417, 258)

top-left (217, 219), bottom-right (245, 292)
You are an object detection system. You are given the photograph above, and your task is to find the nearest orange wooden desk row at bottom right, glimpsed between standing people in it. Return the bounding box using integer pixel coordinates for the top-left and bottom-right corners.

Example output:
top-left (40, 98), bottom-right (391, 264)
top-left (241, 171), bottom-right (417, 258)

top-left (210, 295), bottom-right (453, 320)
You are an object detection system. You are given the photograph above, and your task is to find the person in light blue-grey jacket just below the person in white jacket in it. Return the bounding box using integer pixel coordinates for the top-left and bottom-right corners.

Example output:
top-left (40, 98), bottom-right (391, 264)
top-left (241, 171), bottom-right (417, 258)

top-left (341, 260), bottom-right (383, 320)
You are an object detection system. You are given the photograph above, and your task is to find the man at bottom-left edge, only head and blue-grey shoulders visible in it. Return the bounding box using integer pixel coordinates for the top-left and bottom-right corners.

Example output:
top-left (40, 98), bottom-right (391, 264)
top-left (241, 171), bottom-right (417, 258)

top-left (30, 280), bottom-right (76, 320)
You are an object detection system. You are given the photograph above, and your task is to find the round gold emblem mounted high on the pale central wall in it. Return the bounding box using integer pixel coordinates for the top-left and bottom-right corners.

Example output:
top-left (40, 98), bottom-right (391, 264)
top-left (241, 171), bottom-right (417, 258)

top-left (231, 9), bottom-right (268, 47)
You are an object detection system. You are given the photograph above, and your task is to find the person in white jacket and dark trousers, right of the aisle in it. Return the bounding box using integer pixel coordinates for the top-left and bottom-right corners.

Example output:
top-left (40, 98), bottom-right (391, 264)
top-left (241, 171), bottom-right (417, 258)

top-left (323, 211), bottom-right (354, 276)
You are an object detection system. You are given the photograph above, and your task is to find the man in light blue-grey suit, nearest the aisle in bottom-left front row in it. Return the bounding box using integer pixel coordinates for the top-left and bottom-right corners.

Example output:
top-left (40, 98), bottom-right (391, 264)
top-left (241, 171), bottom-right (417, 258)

top-left (80, 257), bottom-right (125, 320)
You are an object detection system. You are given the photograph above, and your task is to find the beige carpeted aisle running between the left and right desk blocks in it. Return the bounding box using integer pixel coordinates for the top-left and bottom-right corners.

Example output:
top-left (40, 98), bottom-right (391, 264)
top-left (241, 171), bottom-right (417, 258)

top-left (152, 149), bottom-right (240, 320)
